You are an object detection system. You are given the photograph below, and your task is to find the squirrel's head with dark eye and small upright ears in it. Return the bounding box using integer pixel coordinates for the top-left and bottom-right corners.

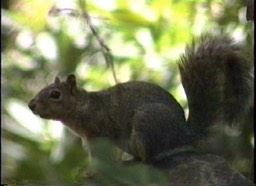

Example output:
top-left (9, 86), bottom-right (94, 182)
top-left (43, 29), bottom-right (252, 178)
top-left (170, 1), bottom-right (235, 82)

top-left (28, 74), bottom-right (78, 120)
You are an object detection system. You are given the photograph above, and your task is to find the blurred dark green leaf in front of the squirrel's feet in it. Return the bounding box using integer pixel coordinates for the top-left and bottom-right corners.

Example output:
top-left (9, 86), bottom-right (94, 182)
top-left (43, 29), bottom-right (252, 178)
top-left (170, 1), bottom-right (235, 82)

top-left (78, 139), bottom-right (170, 185)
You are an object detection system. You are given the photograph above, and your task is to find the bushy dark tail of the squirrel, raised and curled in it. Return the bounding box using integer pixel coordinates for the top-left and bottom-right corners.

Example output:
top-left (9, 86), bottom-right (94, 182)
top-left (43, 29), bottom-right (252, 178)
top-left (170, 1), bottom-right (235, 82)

top-left (179, 34), bottom-right (253, 135)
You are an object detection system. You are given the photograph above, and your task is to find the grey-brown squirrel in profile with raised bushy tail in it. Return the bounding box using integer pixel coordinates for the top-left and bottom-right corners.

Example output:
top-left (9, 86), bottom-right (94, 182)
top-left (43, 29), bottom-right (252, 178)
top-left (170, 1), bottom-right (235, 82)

top-left (28, 34), bottom-right (253, 162)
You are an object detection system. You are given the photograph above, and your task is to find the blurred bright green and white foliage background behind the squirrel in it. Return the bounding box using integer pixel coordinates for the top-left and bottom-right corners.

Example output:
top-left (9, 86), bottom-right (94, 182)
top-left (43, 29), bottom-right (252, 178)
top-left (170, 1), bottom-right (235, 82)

top-left (1, 0), bottom-right (254, 184)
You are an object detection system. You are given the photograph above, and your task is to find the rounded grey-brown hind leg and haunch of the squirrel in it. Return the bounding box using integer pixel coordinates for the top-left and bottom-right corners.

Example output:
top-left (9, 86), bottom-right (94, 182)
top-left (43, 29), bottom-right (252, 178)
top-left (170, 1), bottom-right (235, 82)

top-left (130, 103), bottom-right (189, 162)
